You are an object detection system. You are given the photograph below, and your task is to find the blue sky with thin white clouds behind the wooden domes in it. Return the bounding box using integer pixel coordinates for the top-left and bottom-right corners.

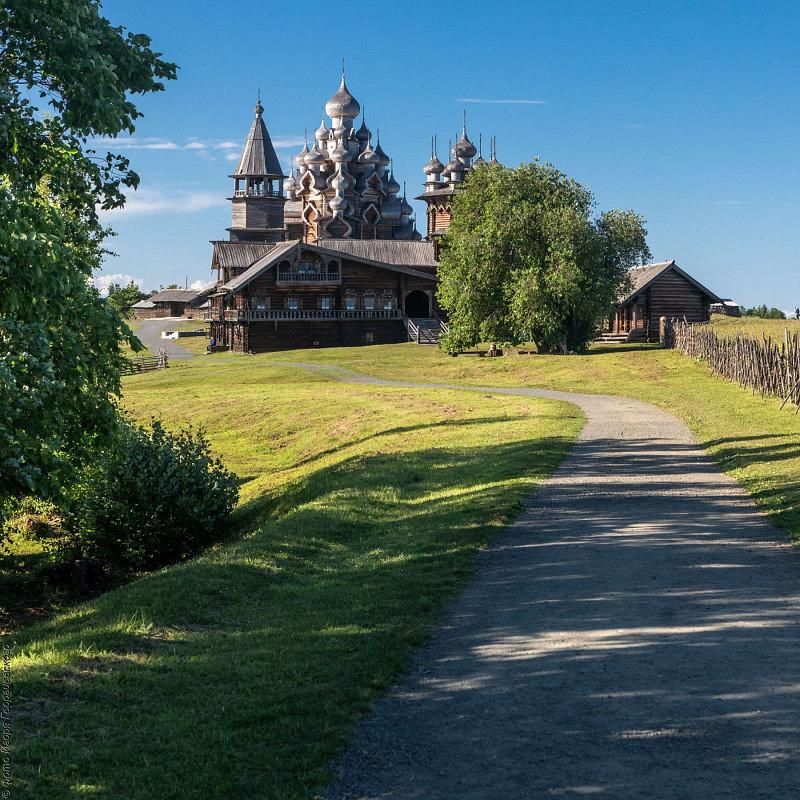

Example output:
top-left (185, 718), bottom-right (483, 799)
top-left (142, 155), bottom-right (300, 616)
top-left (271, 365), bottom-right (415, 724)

top-left (97, 0), bottom-right (800, 309)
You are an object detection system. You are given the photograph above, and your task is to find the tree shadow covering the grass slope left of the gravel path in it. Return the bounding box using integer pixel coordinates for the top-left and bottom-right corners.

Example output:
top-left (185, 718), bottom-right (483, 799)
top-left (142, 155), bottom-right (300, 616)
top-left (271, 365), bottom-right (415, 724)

top-left (14, 438), bottom-right (571, 800)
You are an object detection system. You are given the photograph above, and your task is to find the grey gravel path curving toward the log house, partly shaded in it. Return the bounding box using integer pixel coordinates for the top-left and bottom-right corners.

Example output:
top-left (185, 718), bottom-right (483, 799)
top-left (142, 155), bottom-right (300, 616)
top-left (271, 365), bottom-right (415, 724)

top-left (309, 365), bottom-right (800, 800)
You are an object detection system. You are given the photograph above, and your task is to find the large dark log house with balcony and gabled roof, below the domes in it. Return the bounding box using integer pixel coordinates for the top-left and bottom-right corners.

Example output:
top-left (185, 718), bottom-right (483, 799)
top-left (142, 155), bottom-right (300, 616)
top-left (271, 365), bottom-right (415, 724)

top-left (208, 239), bottom-right (439, 353)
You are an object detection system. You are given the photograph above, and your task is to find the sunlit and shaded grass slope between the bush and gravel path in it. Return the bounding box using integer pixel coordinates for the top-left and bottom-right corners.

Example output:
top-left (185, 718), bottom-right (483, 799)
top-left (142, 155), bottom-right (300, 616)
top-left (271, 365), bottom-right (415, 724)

top-left (12, 362), bottom-right (582, 800)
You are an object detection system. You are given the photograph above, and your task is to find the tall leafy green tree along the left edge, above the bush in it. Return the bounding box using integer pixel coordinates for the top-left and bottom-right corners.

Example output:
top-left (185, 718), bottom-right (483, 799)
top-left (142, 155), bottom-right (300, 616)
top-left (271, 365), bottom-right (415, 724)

top-left (0, 0), bottom-right (176, 500)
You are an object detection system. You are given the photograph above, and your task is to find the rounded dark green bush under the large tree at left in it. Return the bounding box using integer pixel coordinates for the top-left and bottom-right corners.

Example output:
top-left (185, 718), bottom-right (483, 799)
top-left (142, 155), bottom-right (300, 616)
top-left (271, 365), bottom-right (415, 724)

top-left (71, 421), bottom-right (239, 572)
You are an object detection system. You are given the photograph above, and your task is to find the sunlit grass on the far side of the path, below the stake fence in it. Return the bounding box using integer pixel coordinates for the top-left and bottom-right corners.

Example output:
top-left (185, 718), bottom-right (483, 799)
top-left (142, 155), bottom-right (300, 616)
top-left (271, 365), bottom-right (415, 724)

top-left (268, 344), bottom-right (800, 540)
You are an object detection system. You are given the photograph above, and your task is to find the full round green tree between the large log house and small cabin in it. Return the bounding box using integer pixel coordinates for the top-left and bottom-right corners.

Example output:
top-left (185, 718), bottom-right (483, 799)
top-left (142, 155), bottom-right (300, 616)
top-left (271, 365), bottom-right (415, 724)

top-left (438, 162), bottom-right (650, 353)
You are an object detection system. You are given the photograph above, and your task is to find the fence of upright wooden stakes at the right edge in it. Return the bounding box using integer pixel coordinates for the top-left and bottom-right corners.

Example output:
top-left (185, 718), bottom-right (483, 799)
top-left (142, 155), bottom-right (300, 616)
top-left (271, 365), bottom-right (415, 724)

top-left (664, 320), bottom-right (800, 413)
